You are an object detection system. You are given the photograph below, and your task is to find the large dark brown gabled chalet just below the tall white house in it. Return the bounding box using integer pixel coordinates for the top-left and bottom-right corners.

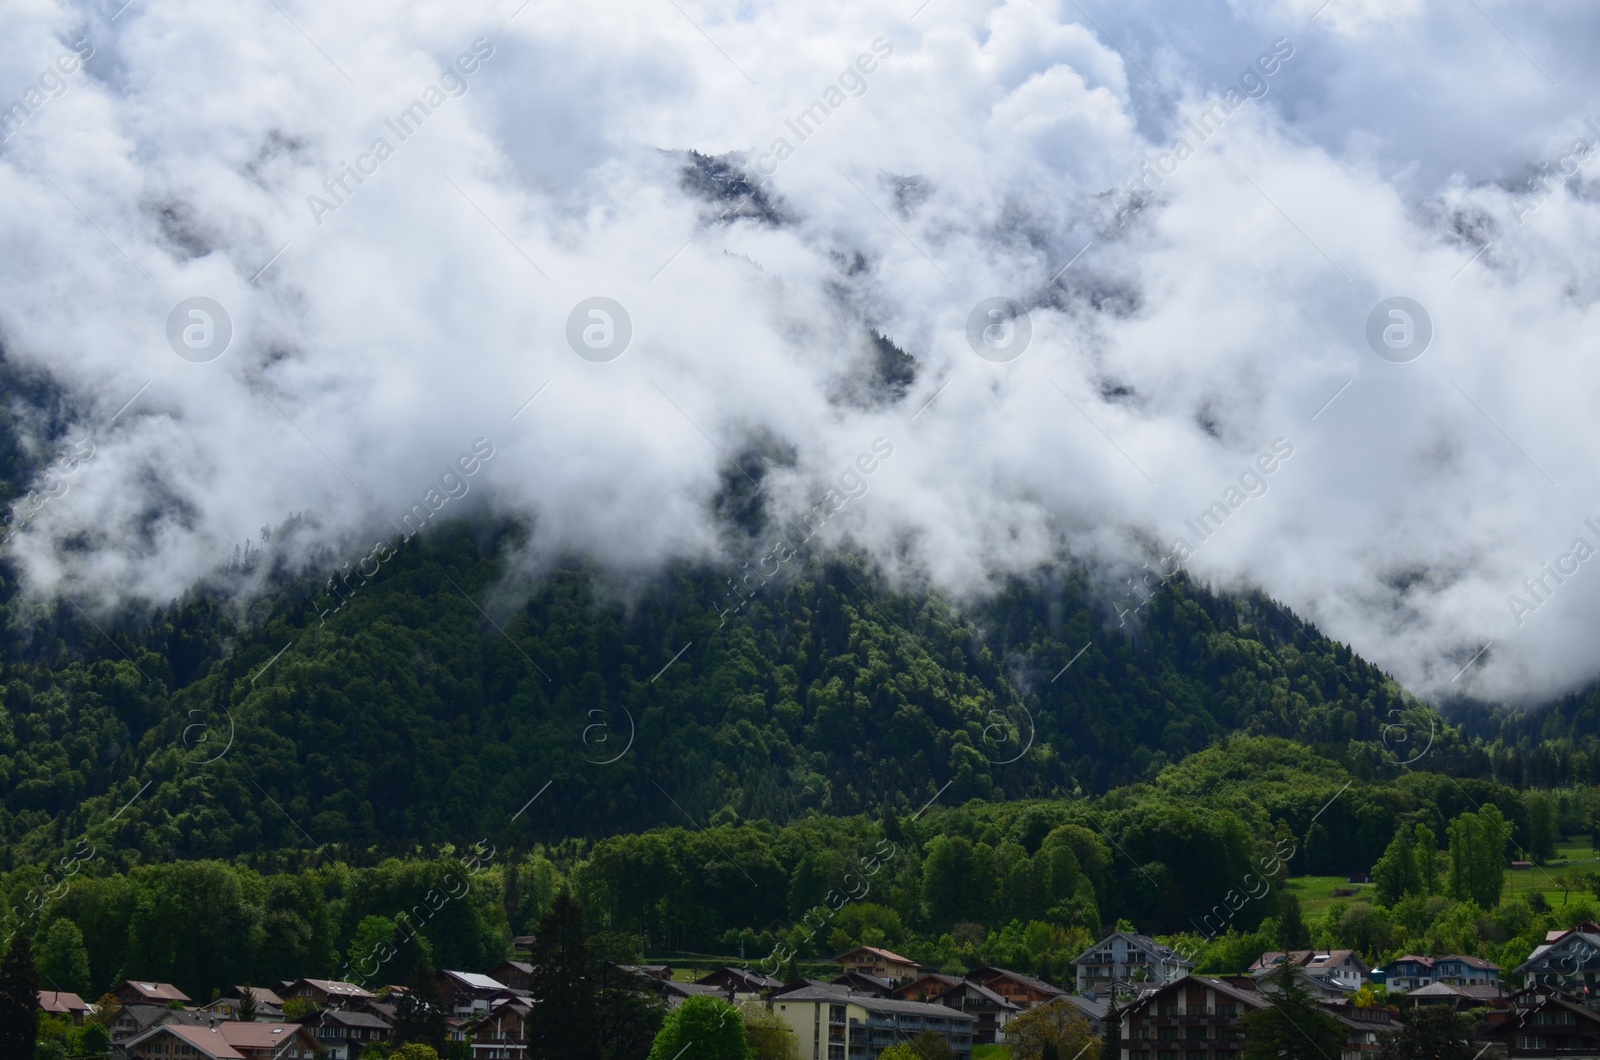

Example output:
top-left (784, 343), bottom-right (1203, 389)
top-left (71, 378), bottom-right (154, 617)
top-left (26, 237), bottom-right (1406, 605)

top-left (1107, 975), bottom-right (1270, 1060)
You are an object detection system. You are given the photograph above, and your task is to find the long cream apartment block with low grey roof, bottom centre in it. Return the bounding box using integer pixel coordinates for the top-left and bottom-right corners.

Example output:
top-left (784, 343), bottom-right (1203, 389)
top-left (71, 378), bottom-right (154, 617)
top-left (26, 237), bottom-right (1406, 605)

top-left (768, 985), bottom-right (978, 1060)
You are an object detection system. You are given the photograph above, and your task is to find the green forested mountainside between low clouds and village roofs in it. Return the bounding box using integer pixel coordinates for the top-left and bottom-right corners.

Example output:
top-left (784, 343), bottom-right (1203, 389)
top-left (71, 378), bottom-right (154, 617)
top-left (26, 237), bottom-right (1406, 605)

top-left (0, 352), bottom-right (1600, 1018)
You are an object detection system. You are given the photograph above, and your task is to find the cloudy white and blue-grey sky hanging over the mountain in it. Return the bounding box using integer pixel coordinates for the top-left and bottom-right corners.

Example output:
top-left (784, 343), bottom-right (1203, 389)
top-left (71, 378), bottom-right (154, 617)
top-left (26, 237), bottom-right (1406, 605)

top-left (0, 0), bottom-right (1600, 703)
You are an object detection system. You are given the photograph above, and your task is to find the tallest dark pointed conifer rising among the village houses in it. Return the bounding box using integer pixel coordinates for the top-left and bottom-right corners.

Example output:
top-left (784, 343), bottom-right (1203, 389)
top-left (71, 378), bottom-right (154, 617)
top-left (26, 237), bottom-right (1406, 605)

top-left (528, 887), bottom-right (601, 1060)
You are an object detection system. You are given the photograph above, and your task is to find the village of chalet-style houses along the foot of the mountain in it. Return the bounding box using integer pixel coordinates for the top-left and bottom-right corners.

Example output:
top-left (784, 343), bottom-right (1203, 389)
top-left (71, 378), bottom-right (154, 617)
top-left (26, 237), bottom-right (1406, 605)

top-left (28, 922), bottom-right (1600, 1060)
